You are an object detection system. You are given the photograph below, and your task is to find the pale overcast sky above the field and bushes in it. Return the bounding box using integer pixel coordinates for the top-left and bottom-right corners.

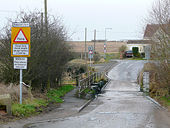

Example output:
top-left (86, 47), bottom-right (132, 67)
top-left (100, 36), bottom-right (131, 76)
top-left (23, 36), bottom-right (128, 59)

top-left (0, 0), bottom-right (156, 40)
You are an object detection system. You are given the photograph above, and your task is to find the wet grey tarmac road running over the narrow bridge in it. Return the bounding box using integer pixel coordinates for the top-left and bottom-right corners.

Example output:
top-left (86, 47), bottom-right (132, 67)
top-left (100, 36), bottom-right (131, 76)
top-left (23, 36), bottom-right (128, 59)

top-left (27, 60), bottom-right (170, 128)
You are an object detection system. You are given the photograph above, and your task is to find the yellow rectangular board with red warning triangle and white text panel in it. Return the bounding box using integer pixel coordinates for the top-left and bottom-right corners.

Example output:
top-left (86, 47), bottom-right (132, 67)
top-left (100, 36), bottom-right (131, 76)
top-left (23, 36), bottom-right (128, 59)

top-left (11, 27), bottom-right (31, 57)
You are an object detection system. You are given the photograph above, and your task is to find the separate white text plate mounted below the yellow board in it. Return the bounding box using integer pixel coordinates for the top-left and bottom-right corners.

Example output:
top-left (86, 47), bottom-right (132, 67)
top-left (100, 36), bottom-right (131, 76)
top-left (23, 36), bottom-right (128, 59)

top-left (14, 57), bottom-right (27, 69)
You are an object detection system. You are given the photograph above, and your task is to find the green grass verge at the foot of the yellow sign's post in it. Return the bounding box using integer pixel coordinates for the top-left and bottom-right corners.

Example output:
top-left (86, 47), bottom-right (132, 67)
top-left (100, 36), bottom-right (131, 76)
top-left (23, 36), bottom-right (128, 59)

top-left (12, 85), bottom-right (74, 117)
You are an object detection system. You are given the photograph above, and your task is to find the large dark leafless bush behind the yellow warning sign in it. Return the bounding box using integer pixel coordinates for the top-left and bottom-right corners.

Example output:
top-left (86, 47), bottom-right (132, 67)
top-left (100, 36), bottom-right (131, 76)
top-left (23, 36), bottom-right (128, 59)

top-left (0, 12), bottom-right (72, 90)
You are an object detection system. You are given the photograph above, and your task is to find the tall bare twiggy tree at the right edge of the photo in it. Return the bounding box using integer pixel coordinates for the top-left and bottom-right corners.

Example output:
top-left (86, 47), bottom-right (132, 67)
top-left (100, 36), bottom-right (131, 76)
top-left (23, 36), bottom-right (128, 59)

top-left (145, 0), bottom-right (170, 95)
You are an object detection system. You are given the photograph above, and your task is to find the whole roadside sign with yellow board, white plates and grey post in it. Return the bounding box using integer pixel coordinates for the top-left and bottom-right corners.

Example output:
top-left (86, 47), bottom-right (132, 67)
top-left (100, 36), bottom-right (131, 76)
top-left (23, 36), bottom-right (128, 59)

top-left (11, 22), bottom-right (31, 104)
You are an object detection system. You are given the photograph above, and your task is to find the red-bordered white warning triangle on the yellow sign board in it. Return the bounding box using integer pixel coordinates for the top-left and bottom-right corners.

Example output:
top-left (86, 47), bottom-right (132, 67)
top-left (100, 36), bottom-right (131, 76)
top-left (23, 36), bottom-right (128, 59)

top-left (13, 29), bottom-right (28, 43)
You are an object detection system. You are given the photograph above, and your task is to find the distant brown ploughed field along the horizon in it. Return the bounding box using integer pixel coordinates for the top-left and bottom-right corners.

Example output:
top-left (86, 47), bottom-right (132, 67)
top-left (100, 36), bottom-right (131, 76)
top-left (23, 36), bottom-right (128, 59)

top-left (67, 41), bottom-right (127, 53)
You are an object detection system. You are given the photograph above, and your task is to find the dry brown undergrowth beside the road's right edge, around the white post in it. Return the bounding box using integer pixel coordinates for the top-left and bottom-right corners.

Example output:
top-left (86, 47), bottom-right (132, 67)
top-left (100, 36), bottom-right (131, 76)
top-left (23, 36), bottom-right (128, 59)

top-left (138, 63), bottom-right (170, 110)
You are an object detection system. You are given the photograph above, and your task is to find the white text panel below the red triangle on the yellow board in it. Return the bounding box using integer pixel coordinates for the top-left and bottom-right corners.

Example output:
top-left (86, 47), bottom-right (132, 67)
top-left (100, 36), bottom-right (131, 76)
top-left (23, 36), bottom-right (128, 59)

top-left (13, 44), bottom-right (29, 55)
